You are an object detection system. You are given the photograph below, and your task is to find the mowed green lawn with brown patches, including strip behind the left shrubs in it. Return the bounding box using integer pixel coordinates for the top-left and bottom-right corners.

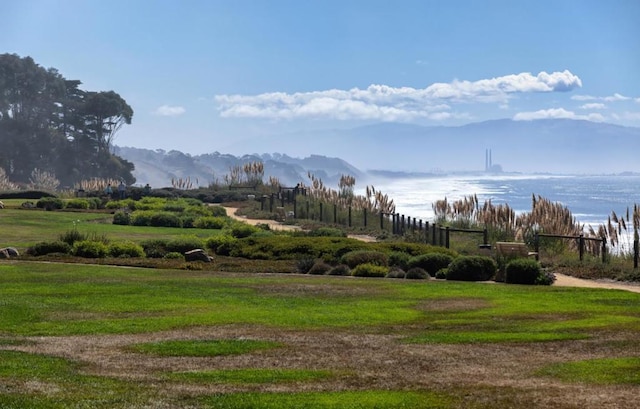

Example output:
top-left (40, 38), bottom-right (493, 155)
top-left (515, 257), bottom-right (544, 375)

top-left (0, 202), bottom-right (640, 408)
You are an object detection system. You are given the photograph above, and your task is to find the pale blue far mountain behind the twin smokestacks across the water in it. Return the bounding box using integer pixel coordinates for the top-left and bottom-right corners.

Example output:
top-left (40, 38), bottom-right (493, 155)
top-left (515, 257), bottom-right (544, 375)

top-left (221, 119), bottom-right (640, 173)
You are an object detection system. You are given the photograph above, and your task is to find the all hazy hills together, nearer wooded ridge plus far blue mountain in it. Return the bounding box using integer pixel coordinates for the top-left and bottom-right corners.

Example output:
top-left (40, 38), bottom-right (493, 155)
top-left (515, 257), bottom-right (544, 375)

top-left (117, 119), bottom-right (640, 186)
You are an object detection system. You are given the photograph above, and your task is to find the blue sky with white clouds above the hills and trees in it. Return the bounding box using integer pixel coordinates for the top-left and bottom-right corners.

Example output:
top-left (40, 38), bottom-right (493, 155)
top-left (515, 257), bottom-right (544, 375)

top-left (5, 0), bottom-right (640, 154)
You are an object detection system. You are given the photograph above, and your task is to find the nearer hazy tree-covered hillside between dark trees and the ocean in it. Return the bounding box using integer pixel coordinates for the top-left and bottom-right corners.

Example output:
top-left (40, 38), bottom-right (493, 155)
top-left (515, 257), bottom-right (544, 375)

top-left (115, 147), bottom-right (366, 187)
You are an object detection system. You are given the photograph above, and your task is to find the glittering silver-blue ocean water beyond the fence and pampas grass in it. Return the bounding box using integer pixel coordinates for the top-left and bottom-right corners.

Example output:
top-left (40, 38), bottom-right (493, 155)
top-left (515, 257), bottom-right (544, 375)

top-left (369, 174), bottom-right (640, 227)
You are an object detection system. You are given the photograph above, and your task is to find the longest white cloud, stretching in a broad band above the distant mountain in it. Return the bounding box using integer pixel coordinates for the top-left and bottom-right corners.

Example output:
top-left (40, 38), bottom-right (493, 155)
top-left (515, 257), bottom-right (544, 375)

top-left (215, 70), bottom-right (582, 121)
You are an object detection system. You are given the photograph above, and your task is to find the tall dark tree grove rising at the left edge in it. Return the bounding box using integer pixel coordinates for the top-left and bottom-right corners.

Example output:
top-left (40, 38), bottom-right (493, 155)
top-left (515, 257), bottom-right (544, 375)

top-left (0, 54), bottom-right (135, 186)
